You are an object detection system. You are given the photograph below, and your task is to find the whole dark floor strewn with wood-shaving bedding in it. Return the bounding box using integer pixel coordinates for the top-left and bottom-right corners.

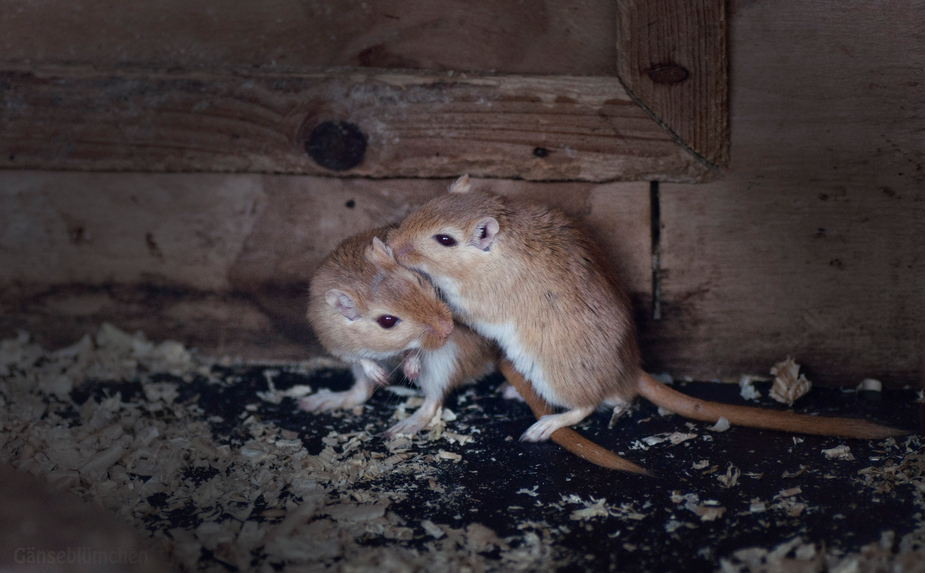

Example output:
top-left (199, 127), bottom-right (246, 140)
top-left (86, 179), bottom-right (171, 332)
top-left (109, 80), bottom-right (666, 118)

top-left (0, 324), bottom-right (925, 573)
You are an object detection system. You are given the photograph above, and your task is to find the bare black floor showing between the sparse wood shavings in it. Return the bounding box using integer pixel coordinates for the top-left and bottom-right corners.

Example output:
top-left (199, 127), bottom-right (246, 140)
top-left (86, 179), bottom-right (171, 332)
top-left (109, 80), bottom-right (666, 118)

top-left (191, 368), bottom-right (923, 571)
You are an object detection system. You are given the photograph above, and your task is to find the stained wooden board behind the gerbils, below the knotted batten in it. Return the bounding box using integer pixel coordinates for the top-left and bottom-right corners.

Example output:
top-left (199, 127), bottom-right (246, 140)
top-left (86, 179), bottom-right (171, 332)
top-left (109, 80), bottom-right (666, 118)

top-left (0, 170), bottom-right (650, 359)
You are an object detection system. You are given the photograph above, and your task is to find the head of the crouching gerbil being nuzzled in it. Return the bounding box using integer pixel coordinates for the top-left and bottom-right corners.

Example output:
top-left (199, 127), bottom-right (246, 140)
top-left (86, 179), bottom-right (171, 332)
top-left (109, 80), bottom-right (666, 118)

top-left (309, 237), bottom-right (453, 358)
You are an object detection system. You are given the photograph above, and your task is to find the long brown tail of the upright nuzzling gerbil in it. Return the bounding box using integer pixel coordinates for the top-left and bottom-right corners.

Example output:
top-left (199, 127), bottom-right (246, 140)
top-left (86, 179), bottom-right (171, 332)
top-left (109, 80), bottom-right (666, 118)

top-left (638, 372), bottom-right (909, 440)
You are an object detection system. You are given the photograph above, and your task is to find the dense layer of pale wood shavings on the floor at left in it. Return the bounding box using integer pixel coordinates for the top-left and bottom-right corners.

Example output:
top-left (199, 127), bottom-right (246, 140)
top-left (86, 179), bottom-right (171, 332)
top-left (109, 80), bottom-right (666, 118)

top-left (0, 324), bottom-right (551, 572)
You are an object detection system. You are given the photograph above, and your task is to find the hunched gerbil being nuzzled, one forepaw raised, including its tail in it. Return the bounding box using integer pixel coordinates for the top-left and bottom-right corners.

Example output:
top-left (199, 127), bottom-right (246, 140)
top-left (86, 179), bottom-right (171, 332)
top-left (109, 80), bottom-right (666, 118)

top-left (299, 228), bottom-right (646, 473)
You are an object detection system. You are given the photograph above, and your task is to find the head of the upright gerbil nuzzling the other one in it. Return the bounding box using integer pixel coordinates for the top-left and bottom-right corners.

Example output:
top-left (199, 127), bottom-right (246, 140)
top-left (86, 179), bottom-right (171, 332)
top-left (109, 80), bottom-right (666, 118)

top-left (388, 175), bottom-right (507, 290)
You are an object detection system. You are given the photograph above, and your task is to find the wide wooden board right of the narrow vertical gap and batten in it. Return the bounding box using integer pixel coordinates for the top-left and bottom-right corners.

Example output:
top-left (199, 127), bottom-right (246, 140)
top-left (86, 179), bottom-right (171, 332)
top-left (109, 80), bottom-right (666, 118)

top-left (645, 0), bottom-right (925, 386)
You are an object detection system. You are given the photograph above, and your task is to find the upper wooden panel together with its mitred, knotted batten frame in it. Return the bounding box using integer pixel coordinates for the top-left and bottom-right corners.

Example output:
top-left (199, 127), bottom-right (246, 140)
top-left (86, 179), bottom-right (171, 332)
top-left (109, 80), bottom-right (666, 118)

top-left (0, 0), bottom-right (728, 182)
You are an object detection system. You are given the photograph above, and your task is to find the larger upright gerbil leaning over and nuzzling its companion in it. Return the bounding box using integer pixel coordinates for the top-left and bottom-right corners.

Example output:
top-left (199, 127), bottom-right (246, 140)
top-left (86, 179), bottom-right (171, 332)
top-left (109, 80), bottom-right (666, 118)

top-left (387, 176), bottom-right (904, 452)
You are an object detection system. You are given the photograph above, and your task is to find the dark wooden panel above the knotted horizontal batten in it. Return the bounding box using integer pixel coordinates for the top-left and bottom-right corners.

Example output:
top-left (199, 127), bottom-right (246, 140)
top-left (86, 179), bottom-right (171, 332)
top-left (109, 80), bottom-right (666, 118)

top-left (0, 0), bottom-right (616, 76)
